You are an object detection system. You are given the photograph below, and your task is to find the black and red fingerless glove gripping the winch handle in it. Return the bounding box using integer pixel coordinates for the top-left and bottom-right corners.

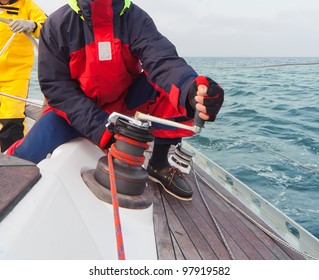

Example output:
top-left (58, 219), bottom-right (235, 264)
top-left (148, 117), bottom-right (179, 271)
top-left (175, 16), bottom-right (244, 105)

top-left (188, 76), bottom-right (224, 122)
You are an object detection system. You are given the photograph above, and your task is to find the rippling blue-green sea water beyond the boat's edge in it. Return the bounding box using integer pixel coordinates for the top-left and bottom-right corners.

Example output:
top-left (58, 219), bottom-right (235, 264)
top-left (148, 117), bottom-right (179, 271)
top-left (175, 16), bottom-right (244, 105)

top-left (29, 57), bottom-right (319, 238)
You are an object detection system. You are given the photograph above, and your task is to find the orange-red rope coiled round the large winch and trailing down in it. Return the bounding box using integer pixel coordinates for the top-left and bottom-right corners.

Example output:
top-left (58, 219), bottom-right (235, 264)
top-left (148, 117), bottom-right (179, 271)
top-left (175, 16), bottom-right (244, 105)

top-left (107, 134), bottom-right (149, 260)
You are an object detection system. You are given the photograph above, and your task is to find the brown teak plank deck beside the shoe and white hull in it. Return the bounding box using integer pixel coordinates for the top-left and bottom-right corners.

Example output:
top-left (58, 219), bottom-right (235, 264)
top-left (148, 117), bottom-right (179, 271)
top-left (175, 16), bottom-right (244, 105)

top-left (150, 162), bottom-right (304, 260)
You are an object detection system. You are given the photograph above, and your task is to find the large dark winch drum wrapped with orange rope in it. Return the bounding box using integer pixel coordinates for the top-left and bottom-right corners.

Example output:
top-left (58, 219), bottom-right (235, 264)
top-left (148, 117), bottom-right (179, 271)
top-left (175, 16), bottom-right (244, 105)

top-left (94, 113), bottom-right (154, 195)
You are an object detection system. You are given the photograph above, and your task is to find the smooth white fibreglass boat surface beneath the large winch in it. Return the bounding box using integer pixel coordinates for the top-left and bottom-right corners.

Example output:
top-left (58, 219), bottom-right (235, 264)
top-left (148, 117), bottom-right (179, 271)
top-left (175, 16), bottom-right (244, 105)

top-left (0, 138), bottom-right (157, 260)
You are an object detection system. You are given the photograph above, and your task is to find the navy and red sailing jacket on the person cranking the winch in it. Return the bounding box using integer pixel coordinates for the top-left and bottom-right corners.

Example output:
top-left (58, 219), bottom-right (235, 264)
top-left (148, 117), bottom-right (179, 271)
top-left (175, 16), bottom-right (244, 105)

top-left (38, 0), bottom-right (197, 147)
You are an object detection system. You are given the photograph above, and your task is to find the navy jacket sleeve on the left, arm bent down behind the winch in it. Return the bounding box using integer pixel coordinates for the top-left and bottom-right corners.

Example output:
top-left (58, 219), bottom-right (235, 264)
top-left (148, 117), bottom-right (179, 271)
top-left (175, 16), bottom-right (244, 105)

top-left (38, 10), bottom-right (108, 145)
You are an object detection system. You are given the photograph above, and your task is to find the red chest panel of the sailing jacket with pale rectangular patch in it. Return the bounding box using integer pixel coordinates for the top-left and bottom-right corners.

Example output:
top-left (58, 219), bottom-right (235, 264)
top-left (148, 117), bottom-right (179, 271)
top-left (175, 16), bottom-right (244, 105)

top-left (70, 1), bottom-right (141, 107)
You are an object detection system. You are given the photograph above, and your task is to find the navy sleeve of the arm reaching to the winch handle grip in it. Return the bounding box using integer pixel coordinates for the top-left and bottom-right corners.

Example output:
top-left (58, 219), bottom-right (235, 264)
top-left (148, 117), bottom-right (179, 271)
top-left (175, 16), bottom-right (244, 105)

top-left (127, 4), bottom-right (198, 114)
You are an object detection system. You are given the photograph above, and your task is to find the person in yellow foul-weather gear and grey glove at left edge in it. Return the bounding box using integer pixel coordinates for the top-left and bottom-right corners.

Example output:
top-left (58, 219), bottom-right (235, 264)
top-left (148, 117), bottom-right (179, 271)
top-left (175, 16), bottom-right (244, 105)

top-left (0, 0), bottom-right (47, 152)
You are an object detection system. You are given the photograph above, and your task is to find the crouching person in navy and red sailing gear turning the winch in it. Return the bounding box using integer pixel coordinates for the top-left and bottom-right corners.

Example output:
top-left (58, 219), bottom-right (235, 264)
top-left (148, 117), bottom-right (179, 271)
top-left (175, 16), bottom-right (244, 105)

top-left (8, 0), bottom-right (224, 200)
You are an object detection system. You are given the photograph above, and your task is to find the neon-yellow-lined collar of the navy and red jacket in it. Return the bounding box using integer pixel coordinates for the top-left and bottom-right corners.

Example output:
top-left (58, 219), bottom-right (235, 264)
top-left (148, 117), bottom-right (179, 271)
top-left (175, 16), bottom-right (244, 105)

top-left (69, 0), bottom-right (131, 22)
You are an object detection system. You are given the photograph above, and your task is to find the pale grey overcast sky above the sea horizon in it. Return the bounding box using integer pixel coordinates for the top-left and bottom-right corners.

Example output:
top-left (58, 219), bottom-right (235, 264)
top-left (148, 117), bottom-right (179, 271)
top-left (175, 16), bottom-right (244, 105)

top-left (34, 0), bottom-right (319, 57)
